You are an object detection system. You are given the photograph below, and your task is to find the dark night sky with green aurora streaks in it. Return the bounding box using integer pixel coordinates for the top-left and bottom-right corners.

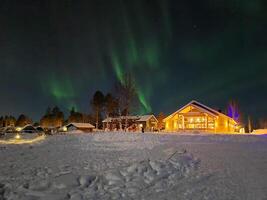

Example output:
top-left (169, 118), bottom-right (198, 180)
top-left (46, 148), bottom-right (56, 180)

top-left (0, 0), bottom-right (267, 120)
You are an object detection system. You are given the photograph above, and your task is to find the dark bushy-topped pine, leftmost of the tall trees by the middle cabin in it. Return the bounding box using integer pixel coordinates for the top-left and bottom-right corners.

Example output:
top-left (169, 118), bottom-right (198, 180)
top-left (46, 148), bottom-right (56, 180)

top-left (91, 91), bottom-right (104, 129)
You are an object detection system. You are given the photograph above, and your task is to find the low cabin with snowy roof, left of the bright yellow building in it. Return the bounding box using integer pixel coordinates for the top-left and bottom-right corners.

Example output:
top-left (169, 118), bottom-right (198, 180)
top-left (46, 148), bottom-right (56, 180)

top-left (102, 115), bottom-right (158, 131)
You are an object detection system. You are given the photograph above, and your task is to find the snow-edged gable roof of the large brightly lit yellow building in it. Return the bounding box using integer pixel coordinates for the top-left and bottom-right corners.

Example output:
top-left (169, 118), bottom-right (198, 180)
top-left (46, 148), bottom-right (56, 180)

top-left (164, 100), bottom-right (238, 121)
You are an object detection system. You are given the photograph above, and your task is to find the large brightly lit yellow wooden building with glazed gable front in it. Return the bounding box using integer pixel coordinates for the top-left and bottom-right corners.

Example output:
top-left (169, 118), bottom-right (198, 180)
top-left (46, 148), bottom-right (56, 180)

top-left (164, 101), bottom-right (240, 133)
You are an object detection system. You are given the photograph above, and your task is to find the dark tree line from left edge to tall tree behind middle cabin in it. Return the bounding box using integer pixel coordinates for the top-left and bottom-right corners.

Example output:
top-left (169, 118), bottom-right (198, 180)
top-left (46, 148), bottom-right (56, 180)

top-left (0, 74), bottom-right (142, 129)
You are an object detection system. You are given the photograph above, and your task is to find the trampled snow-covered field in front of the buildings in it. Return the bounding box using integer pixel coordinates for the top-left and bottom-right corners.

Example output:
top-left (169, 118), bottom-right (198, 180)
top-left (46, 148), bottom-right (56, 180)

top-left (0, 133), bottom-right (267, 200)
